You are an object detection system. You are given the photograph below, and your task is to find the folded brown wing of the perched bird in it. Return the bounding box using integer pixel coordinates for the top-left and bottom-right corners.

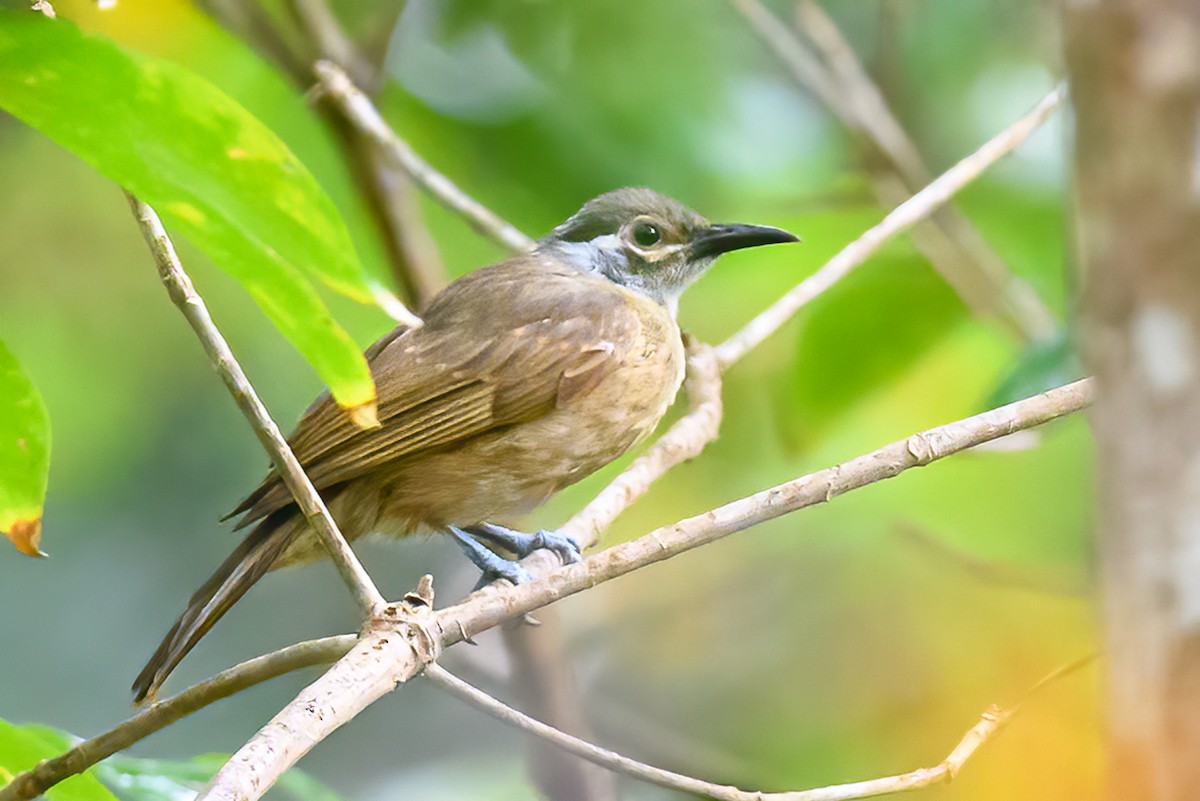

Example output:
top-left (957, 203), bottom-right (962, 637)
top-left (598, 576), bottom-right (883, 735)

top-left (222, 265), bottom-right (640, 526)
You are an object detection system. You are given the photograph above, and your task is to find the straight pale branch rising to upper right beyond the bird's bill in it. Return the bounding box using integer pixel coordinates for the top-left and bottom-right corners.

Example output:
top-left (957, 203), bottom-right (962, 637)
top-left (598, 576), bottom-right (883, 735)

top-left (716, 86), bottom-right (1067, 367)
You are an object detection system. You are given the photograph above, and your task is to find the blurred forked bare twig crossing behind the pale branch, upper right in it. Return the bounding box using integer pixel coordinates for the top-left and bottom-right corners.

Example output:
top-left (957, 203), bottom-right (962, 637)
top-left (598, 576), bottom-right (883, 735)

top-left (731, 0), bottom-right (1057, 341)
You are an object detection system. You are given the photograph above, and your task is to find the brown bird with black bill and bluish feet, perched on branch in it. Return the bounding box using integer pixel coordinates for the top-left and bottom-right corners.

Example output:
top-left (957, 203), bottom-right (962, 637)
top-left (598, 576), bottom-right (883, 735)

top-left (132, 187), bottom-right (799, 703)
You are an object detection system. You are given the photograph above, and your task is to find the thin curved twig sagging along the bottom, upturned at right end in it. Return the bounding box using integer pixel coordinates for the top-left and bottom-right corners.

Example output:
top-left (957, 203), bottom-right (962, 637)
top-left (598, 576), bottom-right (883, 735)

top-left (425, 656), bottom-right (1094, 801)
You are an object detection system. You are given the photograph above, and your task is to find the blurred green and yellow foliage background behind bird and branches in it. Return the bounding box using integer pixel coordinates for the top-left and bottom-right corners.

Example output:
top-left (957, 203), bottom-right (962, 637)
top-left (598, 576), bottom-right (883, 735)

top-left (0, 0), bottom-right (1100, 801)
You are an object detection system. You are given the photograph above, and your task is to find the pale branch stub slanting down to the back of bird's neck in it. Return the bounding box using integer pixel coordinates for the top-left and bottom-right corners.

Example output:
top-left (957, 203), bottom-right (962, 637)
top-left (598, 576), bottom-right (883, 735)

top-left (313, 61), bottom-right (534, 253)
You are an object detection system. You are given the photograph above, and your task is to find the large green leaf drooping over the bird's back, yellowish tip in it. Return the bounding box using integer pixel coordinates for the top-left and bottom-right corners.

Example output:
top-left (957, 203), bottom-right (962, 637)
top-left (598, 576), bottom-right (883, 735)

top-left (0, 11), bottom-right (374, 406)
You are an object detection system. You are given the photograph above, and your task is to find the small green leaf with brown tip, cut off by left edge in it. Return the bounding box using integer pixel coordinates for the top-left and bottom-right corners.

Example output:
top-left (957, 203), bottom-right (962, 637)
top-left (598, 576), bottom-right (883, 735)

top-left (0, 342), bottom-right (50, 556)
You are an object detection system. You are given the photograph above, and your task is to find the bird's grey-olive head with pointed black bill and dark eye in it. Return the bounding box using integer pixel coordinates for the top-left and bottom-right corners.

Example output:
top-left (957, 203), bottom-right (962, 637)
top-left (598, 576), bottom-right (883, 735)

top-left (538, 188), bottom-right (799, 313)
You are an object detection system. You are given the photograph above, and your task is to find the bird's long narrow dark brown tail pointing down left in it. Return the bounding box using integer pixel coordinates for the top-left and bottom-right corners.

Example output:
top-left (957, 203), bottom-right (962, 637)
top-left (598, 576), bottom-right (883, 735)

top-left (132, 507), bottom-right (298, 704)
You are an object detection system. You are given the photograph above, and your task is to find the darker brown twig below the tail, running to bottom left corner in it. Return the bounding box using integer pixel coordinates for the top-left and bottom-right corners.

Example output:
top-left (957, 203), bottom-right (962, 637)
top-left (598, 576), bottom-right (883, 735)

top-left (0, 634), bottom-right (358, 801)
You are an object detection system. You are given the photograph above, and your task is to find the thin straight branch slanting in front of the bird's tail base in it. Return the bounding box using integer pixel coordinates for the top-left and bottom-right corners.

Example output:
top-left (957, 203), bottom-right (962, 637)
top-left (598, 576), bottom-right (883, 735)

top-left (126, 193), bottom-right (386, 618)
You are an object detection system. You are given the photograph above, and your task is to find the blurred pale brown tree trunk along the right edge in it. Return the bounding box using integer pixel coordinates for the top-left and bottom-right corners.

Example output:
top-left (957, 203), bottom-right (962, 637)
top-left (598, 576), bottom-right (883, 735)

top-left (1064, 0), bottom-right (1200, 801)
